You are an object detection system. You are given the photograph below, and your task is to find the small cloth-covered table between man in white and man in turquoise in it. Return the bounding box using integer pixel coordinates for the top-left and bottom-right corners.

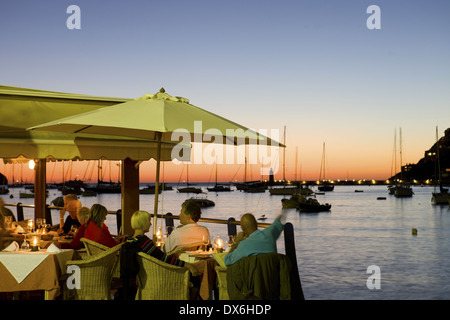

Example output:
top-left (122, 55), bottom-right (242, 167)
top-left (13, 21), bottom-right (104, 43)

top-left (179, 251), bottom-right (219, 300)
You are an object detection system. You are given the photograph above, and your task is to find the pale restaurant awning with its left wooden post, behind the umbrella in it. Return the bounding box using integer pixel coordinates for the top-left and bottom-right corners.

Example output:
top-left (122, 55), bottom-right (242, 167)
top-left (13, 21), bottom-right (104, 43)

top-left (0, 85), bottom-right (186, 224)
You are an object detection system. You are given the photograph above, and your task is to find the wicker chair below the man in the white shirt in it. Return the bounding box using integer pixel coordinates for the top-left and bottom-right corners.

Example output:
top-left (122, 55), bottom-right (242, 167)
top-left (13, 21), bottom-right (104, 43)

top-left (136, 252), bottom-right (192, 300)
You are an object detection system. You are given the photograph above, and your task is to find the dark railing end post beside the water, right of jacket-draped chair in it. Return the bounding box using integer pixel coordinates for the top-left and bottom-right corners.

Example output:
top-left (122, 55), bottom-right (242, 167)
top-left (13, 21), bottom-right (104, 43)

top-left (284, 222), bottom-right (305, 300)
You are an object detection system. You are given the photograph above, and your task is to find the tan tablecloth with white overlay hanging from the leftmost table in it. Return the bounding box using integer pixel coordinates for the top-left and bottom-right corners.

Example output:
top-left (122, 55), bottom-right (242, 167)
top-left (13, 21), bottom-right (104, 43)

top-left (0, 249), bottom-right (75, 300)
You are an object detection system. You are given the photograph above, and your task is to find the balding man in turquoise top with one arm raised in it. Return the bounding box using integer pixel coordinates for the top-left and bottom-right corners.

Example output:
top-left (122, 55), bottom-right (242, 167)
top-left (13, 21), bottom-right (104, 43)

top-left (224, 213), bottom-right (283, 266)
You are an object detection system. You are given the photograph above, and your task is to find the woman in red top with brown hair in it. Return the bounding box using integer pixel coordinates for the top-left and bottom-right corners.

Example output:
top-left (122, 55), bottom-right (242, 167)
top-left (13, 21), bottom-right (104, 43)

top-left (72, 204), bottom-right (119, 249)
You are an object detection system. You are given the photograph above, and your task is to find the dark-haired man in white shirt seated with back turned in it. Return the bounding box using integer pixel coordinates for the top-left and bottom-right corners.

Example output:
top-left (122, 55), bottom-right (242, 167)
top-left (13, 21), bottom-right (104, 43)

top-left (162, 200), bottom-right (209, 252)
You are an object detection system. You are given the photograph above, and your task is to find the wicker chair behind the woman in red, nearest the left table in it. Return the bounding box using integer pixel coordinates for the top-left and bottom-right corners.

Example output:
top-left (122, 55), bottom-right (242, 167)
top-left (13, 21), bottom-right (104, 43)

top-left (65, 244), bottom-right (122, 300)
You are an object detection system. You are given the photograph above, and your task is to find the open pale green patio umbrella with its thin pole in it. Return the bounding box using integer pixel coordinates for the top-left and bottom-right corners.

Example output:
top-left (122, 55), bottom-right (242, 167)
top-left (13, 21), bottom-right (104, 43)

top-left (29, 89), bottom-right (284, 234)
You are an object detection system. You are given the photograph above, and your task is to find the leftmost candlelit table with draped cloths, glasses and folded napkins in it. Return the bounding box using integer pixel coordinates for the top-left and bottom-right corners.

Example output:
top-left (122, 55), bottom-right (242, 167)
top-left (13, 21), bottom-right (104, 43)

top-left (0, 220), bottom-right (77, 300)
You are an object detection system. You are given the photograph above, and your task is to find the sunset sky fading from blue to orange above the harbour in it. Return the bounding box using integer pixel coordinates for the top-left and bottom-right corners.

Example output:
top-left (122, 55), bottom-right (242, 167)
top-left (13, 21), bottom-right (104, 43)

top-left (0, 0), bottom-right (450, 182)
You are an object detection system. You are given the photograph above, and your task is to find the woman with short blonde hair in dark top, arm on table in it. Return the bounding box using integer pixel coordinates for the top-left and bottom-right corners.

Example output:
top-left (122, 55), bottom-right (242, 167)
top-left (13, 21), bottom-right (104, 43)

top-left (119, 211), bottom-right (196, 300)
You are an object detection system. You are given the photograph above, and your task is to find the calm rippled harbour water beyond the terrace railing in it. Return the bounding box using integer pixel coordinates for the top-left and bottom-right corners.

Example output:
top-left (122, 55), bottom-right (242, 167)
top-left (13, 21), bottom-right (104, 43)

top-left (7, 185), bottom-right (450, 300)
